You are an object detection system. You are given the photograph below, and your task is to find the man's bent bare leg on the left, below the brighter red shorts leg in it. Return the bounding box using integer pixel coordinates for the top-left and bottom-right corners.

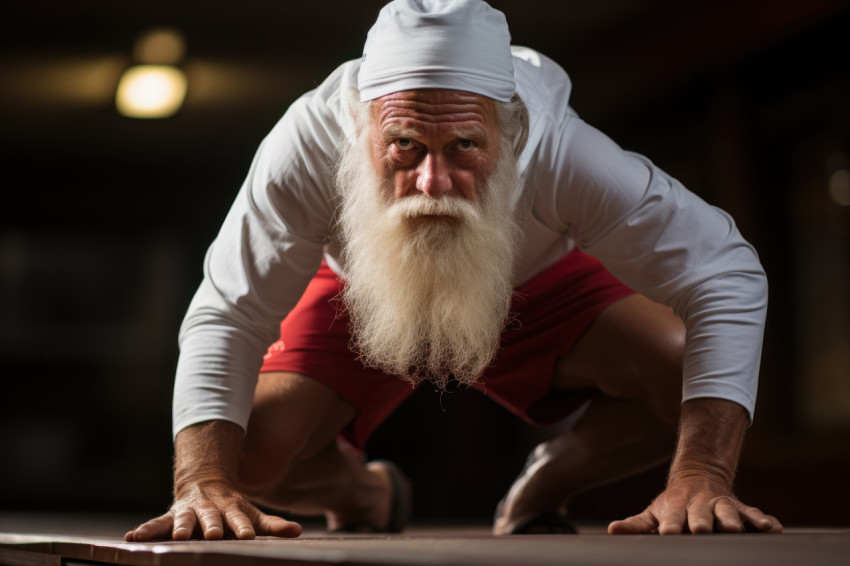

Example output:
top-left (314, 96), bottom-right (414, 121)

top-left (239, 372), bottom-right (392, 529)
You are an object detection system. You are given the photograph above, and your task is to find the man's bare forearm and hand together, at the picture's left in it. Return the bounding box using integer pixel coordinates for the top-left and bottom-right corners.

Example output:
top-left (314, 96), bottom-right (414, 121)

top-left (124, 421), bottom-right (301, 542)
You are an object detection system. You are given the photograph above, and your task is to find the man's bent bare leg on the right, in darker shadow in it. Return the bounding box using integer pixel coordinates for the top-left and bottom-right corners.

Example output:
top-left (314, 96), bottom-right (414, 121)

top-left (493, 295), bottom-right (684, 534)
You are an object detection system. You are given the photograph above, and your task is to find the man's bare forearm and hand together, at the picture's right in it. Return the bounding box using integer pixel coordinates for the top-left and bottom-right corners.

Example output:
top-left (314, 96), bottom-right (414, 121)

top-left (608, 399), bottom-right (782, 535)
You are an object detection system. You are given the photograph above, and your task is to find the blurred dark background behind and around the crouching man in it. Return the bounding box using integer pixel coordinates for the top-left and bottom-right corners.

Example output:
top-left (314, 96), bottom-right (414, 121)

top-left (0, 0), bottom-right (850, 525)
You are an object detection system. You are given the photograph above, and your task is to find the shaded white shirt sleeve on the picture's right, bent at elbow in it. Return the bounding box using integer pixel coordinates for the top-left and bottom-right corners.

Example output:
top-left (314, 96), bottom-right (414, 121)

top-left (535, 115), bottom-right (767, 419)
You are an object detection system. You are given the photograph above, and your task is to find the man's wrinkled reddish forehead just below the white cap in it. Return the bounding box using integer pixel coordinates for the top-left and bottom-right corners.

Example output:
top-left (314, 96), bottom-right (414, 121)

top-left (370, 89), bottom-right (498, 134)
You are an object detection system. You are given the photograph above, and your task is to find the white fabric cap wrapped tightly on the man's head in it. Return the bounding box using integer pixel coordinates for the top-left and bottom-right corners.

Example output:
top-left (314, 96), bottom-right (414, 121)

top-left (357, 0), bottom-right (516, 102)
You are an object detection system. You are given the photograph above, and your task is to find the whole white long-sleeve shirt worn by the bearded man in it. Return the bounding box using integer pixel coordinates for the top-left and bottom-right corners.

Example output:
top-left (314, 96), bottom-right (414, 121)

top-left (173, 47), bottom-right (767, 435)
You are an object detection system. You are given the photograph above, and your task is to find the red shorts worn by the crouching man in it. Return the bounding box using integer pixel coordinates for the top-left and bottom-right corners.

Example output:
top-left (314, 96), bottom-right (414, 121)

top-left (260, 250), bottom-right (633, 449)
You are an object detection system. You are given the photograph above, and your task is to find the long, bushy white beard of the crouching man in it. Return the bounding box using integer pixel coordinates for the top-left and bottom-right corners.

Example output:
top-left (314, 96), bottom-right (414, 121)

top-left (337, 135), bottom-right (521, 388)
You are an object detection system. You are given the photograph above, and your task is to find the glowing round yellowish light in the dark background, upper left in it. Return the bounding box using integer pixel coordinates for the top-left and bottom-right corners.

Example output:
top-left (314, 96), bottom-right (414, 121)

top-left (115, 65), bottom-right (187, 118)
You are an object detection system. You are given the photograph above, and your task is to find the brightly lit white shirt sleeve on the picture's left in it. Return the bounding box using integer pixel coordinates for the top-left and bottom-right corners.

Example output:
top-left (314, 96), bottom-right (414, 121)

top-left (173, 97), bottom-right (339, 436)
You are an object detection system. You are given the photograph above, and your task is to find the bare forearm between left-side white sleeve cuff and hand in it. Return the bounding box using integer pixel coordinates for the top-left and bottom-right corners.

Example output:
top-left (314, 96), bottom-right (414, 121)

top-left (174, 420), bottom-right (245, 496)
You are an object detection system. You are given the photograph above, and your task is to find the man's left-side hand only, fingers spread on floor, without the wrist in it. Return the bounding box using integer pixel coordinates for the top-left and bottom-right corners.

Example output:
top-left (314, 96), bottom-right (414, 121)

top-left (124, 481), bottom-right (301, 542)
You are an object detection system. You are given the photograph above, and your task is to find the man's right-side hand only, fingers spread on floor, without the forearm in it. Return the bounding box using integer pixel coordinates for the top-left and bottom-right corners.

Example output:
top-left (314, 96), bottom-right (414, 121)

top-left (608, 476), bottom-right (782, 535)
